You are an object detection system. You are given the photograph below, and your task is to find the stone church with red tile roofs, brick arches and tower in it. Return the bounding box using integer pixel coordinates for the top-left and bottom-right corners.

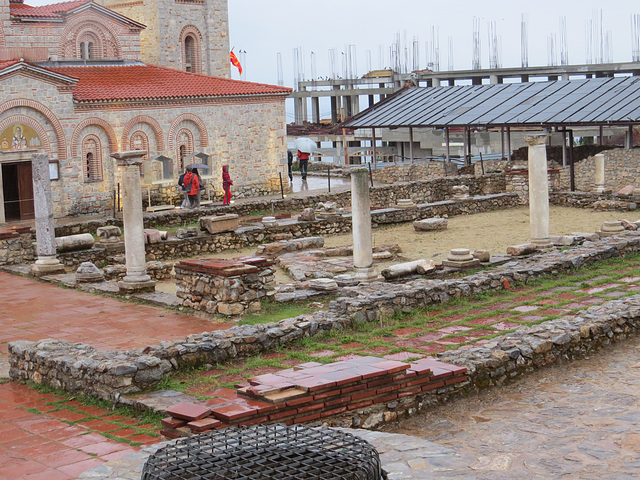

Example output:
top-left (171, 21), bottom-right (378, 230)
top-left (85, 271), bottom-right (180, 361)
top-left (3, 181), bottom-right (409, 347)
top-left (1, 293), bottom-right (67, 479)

top-left (0, 0), bottom-right (290, 223)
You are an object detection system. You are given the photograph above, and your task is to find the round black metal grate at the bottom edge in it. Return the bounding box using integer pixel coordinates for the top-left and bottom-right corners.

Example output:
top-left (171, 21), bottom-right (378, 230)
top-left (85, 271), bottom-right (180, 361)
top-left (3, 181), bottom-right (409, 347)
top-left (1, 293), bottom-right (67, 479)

top-left (142, 424), bottom-right (386, 480)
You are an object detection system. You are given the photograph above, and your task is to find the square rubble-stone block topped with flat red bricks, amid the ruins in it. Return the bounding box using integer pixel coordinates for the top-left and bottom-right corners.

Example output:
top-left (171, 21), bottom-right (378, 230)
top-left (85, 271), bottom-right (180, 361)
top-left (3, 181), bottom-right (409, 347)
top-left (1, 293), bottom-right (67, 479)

top-left (175, 257), bottom-right (276, 315)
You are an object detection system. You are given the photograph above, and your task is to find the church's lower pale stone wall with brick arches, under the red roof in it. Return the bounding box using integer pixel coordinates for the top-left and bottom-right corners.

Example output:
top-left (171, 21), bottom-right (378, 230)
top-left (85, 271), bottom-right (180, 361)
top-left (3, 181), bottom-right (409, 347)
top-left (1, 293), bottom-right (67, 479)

top-left (0, 71), bottom-right (286, 217)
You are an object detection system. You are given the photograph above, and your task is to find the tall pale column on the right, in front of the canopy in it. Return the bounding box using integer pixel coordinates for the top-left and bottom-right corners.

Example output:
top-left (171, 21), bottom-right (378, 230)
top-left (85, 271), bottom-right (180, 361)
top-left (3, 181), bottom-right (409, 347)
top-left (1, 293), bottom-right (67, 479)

top-left (524, 133), bottom-right (553, 250)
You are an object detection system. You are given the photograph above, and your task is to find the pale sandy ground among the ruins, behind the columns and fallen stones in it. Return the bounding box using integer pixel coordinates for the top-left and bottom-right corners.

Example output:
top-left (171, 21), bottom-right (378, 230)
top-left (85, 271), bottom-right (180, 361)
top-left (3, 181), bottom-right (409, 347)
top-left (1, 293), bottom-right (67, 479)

top-left (157, 207), bottom-right (637, 292)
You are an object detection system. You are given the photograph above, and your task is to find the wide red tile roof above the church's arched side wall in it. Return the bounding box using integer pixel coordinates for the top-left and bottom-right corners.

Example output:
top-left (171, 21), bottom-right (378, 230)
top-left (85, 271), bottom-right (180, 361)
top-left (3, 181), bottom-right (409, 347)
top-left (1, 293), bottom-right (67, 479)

top-left (45, 64), bottom-right (291, 102)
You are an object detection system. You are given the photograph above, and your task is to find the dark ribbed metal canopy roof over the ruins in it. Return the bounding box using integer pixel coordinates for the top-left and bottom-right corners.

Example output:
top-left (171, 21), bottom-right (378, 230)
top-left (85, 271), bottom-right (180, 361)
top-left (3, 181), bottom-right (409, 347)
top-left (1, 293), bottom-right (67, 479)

top-left (345, 77), bottom-right (640, 128)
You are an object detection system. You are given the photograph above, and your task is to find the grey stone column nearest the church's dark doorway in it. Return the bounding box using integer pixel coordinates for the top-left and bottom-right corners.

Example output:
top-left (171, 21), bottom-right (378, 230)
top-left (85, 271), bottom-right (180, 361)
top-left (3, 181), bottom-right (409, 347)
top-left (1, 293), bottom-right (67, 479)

top-left (31, 153), bottom-right (64, 277)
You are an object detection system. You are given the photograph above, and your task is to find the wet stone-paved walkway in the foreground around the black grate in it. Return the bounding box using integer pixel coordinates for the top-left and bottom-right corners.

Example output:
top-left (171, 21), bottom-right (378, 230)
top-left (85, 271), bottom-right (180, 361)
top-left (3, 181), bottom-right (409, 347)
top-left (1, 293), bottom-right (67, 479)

top-left (80, 337), bottom-right (640, 480)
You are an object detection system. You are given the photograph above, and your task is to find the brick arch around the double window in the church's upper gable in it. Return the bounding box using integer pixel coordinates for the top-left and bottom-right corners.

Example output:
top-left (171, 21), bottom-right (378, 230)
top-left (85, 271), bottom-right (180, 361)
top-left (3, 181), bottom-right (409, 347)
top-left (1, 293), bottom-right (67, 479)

top-left (59, 17), bottom-right (122, 58)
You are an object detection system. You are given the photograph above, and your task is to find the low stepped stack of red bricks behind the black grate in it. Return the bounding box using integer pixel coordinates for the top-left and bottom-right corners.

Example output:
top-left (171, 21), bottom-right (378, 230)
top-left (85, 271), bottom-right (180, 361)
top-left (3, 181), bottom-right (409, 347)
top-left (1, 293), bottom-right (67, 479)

top-left (161, 357), bottom-right (467, 438)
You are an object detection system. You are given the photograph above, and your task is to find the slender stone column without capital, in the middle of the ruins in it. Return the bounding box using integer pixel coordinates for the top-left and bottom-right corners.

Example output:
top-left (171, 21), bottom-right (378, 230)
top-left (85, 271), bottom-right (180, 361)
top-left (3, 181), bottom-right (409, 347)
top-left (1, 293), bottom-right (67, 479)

top-left (351, 167), bottom-right (379, 282)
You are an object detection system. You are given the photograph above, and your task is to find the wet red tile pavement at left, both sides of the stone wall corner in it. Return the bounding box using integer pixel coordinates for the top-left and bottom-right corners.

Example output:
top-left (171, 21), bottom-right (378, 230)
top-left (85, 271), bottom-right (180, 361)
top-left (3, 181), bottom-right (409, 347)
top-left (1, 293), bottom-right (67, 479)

top-left (0, 272), bottom-right (230, 480)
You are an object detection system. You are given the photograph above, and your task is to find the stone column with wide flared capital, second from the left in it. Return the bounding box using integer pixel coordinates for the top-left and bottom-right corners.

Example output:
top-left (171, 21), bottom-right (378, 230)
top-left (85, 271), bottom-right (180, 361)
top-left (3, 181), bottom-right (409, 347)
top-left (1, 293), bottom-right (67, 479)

top-left (111, 150), bottom-right (156, 293)
